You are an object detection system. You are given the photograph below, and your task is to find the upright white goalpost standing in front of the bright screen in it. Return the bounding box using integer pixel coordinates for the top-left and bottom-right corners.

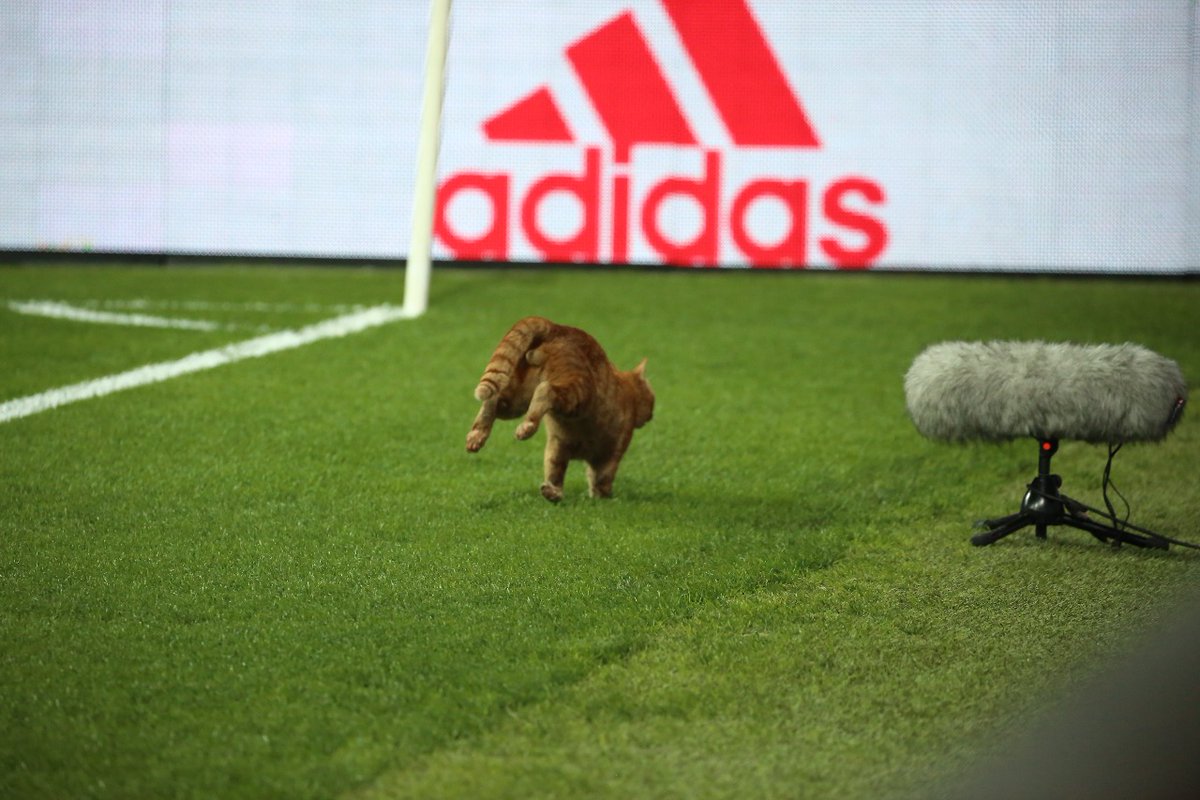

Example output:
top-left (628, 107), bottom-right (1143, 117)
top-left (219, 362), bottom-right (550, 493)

top-left (403, 0), bottom-right (450, 317)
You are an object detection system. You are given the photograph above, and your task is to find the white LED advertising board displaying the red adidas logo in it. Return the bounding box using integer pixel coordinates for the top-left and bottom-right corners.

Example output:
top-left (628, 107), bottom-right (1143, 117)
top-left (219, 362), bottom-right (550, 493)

top-left (0, 0), bottom-right (1200, 273)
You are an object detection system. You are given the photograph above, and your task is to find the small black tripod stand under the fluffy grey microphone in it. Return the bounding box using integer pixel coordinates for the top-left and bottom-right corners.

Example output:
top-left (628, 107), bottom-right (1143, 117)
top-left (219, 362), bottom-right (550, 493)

top-left (971, 439), bottom-right (1168, 551)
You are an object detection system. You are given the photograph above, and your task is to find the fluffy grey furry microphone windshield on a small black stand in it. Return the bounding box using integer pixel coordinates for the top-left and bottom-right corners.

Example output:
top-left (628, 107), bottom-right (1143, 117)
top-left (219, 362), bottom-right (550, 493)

top-left (905, 342), bottom-right (1187, 444)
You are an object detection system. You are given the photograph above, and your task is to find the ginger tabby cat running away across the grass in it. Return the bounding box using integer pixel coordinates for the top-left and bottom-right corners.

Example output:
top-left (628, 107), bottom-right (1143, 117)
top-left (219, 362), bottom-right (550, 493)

top-left (467, 317), bottom-right (654, 503)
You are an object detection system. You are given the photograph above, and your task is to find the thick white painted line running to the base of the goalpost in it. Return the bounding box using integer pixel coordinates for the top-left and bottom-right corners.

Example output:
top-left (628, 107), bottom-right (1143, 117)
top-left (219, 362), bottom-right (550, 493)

top-left (0, 306), bottom-right (412, 422)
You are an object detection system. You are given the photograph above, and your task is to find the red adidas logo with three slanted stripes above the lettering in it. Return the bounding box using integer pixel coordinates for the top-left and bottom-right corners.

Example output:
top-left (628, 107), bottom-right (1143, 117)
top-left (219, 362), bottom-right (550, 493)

top-left (434, 0), bottom-right (888, 269)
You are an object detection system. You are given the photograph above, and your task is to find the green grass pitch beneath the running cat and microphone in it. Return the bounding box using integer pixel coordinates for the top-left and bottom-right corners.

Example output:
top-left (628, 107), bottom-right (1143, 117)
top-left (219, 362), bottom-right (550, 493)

top-left (0, 265), bottom-right (1200, 800)
